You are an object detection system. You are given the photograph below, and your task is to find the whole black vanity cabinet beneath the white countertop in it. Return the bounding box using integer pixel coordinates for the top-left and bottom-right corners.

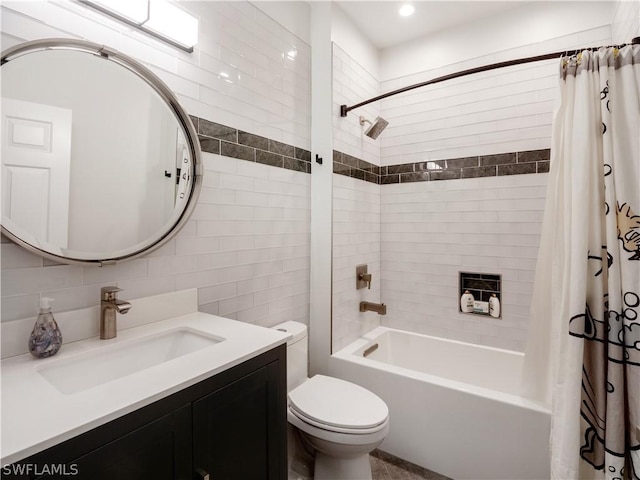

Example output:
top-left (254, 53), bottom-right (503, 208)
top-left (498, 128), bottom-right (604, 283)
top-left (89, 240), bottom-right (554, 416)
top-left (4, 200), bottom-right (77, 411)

top-left (2, 345), bottom-right (287, 480)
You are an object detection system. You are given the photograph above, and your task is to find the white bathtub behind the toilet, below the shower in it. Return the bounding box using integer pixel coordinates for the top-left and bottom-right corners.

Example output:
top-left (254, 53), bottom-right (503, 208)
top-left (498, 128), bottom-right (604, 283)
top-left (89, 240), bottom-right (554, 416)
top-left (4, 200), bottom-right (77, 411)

top-left (329, 327), bottom-right (551, 480)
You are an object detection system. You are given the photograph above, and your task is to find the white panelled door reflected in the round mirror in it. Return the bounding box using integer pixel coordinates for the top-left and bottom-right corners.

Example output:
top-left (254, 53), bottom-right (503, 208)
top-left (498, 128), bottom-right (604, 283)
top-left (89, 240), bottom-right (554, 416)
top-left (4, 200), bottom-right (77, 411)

top-left (1, 98), bottom-right (71, 248)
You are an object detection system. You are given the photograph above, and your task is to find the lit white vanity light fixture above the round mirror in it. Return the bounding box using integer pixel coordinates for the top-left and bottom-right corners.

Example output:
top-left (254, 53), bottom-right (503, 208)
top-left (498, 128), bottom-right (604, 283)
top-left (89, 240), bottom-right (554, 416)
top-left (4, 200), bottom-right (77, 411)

top-left (80, 0), bottom-right (198, 52)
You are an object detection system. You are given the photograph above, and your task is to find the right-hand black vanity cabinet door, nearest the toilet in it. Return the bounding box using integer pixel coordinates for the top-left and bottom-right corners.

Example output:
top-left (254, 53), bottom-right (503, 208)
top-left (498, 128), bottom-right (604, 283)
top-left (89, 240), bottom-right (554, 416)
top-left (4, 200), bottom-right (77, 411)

top-left (193, 362), bottom-right (286, 480)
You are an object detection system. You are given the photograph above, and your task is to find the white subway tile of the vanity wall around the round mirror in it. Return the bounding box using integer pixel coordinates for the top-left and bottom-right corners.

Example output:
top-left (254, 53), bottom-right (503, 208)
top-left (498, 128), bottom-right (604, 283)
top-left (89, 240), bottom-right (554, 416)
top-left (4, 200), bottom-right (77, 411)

top-left (0, 0), bottom-right (311, 326)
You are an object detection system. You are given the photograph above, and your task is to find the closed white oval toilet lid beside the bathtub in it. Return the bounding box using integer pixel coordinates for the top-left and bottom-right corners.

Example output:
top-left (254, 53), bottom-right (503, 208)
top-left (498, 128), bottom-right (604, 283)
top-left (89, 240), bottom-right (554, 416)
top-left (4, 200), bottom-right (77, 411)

top-left (289, 375), bottom-right (389, 429)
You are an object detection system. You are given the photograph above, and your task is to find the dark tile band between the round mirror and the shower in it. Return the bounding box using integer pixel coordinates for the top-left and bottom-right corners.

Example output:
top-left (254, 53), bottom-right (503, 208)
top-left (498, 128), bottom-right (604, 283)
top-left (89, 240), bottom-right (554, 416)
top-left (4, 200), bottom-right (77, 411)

top-left (191, 116), bottom-right (311, 173)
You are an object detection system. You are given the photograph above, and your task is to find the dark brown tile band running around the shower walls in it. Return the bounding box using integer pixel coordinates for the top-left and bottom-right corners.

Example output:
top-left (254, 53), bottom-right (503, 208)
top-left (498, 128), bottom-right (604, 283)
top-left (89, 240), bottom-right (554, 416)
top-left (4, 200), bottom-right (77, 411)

top-left (333, 148), bottom-right (551, 185)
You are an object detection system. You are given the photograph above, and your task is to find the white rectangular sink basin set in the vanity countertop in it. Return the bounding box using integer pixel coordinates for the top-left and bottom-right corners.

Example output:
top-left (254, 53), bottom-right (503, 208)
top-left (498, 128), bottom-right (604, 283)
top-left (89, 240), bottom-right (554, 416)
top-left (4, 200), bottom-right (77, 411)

top-left (38, 328), bottom-right (224, 394)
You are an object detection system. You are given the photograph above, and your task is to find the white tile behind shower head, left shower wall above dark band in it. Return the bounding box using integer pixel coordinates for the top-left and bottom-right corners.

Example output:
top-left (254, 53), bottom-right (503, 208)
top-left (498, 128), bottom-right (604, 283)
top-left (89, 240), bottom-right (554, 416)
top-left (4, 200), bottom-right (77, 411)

top-left (333, 43), bottom-right (380, 165)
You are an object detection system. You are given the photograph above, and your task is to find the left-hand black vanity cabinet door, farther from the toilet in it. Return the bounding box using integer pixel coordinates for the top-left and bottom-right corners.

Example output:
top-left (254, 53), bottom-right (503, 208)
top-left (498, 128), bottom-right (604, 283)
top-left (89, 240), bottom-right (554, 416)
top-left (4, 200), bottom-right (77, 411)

top-left (32, 406), bottom-right (192, 480)
